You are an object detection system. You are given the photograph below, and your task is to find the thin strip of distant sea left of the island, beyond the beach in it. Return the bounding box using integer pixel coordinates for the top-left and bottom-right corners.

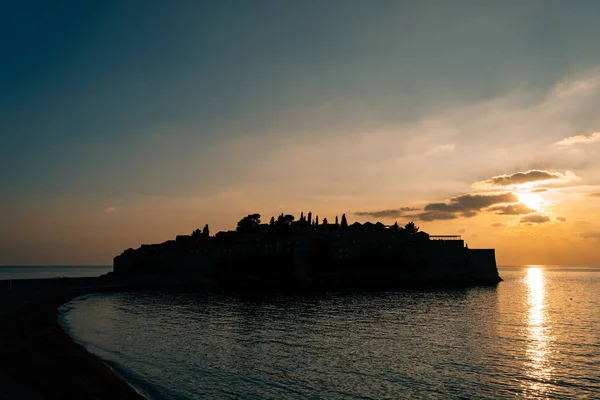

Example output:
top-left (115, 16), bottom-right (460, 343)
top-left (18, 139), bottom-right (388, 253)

top-left (0, 266), bottom-right (112, 280)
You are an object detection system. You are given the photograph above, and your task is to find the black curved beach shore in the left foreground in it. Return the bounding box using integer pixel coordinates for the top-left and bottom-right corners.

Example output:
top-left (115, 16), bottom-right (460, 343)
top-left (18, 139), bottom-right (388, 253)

top-left (0, 278), bottom-right (143, 400)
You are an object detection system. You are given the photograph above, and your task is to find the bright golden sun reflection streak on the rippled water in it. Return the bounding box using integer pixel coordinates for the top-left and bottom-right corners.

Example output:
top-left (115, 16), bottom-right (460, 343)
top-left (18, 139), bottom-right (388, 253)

top-left (525, 268), bottom-right (552, 394)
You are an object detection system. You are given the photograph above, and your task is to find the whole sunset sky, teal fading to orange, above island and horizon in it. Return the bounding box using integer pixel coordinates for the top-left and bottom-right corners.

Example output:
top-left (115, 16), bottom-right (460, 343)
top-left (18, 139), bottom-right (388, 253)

top-left (0, 0), bottom-right (600, 265)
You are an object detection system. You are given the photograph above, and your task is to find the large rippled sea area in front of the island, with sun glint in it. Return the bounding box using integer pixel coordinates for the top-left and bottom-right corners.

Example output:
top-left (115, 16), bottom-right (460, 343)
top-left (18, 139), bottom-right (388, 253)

top-left (61, 267), bottom-right (600, 399)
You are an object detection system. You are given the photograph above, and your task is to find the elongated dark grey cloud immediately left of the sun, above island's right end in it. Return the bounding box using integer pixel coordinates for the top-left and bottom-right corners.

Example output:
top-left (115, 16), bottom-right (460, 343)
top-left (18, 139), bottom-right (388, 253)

top-left (424, 192), bottom-right (519, 217)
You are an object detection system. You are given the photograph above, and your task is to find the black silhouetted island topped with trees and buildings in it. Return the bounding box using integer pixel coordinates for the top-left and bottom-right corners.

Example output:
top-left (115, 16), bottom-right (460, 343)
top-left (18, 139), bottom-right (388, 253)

top-left (113, 212), bottom-right (502, 289)
